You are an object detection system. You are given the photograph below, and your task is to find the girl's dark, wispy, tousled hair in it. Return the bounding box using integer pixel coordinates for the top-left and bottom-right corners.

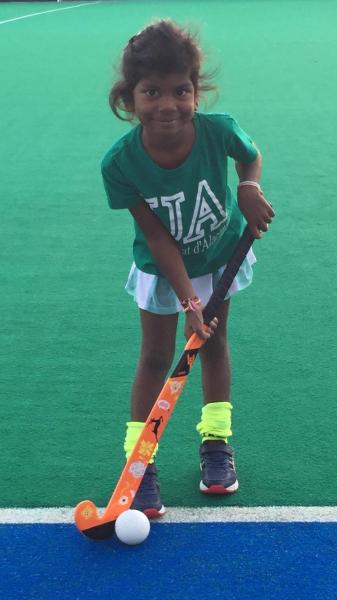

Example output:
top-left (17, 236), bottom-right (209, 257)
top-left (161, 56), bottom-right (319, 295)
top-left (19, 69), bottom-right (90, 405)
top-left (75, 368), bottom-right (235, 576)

top-left (109, 19), bottom-right (216, 121)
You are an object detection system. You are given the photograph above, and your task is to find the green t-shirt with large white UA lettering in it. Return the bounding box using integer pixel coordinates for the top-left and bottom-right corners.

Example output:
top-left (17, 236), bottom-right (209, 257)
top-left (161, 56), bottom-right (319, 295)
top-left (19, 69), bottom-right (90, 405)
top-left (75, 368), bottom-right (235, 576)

top-left (102, 113), bottom-right (257, 277)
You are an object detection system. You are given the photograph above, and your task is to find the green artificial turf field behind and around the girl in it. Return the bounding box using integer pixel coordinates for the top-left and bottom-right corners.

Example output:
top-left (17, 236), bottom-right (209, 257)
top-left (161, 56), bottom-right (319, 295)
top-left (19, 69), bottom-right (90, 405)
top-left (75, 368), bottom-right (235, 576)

top-left (0, 0), bottom-right (337, 507)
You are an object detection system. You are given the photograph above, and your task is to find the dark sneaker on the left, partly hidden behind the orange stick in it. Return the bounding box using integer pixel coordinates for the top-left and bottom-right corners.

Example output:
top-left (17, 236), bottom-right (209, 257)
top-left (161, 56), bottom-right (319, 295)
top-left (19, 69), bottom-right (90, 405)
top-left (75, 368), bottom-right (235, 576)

top-left (131, 463), bottom-right (166, 519)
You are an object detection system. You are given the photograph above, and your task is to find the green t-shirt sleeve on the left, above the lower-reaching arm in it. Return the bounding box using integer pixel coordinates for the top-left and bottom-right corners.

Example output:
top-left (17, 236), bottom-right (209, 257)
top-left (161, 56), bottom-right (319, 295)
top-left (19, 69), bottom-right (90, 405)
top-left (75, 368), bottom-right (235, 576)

top-left (101, 159), bottom-right (143, 209)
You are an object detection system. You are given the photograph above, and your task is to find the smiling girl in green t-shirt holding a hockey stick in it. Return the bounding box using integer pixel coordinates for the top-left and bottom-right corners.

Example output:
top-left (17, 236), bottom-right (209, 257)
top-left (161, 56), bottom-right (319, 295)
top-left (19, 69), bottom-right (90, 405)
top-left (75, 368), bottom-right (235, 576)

top-left (102, 20), bottom-right (274, 517)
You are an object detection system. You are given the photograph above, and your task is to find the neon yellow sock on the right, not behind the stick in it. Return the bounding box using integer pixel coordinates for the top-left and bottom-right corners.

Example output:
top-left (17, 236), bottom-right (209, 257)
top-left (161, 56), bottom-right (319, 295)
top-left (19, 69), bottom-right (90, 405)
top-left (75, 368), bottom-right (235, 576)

top-left (197, 402), bottom-right (233, 442)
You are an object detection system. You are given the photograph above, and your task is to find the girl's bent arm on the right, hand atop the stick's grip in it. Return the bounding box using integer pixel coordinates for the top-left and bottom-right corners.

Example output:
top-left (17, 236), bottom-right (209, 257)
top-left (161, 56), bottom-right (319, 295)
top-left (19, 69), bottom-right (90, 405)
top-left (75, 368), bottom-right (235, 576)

top-left (235, 152), bottom-right (275, 238)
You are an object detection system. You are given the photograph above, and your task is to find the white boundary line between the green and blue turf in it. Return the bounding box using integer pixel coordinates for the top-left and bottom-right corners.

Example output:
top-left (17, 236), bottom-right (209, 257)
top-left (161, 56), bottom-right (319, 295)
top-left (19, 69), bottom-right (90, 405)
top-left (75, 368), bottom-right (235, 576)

top-left (0, 506), bottom-right (337, 525)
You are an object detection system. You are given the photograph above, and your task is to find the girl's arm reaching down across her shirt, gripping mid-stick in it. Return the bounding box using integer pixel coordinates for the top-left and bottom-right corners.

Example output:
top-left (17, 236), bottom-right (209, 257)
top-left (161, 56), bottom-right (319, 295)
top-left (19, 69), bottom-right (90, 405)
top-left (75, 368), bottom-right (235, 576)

top-left (130, 202), bottom-right (216, 339)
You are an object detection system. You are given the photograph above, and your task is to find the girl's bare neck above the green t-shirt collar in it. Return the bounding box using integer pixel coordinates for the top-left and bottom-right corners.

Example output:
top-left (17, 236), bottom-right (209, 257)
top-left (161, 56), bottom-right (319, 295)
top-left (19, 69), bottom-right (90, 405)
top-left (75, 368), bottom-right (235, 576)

top-left (142, 121), bottom-right (195, 169)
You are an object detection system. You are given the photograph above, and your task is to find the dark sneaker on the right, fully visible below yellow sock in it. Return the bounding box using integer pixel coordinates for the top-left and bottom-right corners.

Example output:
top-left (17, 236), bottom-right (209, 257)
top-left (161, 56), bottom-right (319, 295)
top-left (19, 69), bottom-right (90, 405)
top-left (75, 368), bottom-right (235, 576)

top-left (200, 440), bottom-right (239, 494)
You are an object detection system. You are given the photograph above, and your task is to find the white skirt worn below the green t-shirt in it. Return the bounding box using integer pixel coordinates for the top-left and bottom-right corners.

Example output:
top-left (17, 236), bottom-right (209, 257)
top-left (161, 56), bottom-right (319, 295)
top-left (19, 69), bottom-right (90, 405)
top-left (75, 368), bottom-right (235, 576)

top-left (125, 249), bottom-right (256, 315)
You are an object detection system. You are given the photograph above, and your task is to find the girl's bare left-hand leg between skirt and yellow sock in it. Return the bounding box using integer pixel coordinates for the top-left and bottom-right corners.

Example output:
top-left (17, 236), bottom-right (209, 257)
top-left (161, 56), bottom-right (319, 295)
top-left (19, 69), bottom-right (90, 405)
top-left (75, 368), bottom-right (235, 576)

top-left (131, 310), bottom-right (178, 422)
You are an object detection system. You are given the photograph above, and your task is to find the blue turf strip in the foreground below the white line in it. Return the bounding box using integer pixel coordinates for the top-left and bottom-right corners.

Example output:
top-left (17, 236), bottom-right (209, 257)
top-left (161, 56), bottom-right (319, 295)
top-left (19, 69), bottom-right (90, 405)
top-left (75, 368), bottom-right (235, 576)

top-left (0, 523), bottom-right (337, 600)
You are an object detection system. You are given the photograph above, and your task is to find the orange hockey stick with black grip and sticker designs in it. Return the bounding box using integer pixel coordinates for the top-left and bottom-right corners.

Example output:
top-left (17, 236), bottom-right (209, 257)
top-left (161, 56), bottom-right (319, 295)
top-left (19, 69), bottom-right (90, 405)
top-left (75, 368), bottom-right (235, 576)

top-left (75, 227), bottom-right (254, 539)
